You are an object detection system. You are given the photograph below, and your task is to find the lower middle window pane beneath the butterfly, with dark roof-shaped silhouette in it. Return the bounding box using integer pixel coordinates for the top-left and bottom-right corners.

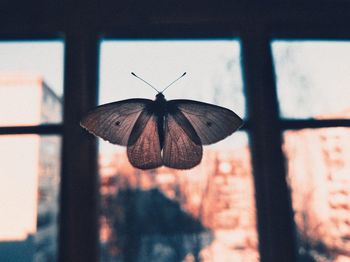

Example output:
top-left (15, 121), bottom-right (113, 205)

top-left (100, 133), bottom-right (258, 261)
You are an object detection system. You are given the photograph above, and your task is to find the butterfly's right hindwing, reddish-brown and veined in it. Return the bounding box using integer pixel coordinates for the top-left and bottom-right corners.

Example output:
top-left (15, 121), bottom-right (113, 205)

top-left (163, 110), bottom-right (203, 169)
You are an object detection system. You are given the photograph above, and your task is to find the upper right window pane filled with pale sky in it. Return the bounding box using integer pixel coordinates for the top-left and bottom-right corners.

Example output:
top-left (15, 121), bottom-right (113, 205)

top-left (272, 41), bottom-right (350, 119)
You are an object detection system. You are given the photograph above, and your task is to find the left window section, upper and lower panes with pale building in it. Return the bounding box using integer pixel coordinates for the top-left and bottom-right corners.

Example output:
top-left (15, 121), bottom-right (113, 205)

top-left (0, 41), bottom-right (63, 261)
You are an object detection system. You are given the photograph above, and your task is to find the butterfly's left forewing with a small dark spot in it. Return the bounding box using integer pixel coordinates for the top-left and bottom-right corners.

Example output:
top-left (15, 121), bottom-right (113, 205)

top-left (80, 99), bottom-right (153, 146)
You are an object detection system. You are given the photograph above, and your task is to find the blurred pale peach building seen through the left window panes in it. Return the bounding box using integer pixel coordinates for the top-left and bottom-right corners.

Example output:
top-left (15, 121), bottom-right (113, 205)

top-left (0, 74), bottom-right (62, 262)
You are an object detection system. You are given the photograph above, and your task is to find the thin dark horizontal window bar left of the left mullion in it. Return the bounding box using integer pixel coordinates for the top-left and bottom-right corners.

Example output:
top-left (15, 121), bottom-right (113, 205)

top-left (0, 124), bottom-right (63, 135)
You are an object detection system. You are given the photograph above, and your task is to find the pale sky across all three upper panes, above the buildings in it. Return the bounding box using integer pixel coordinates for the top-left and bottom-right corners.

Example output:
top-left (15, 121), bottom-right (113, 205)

top-left (0, 39), bottom-right (350, 118)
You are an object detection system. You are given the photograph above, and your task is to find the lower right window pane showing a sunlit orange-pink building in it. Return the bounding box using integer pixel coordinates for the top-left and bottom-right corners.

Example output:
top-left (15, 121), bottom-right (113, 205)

top-left (284, 127), bottom-right (350, 262)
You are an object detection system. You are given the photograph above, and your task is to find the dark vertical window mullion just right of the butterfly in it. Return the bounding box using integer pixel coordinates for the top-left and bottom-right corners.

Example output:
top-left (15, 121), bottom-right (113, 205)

top-left (242, 26), bottom-right (296, 261)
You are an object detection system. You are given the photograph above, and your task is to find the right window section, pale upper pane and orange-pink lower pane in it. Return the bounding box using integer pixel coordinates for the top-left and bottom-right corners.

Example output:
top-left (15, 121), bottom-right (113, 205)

top-left (272, 41), bottom-right (350, 261)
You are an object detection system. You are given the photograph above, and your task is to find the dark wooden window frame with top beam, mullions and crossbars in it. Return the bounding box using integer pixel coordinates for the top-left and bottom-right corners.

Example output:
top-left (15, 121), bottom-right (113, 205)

top-left (0, 0), bottom-right (350, 262)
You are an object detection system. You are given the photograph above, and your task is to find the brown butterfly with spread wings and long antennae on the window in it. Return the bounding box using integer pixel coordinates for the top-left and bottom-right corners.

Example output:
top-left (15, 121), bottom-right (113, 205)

top-left (80, 73), bottom-right (243, 170)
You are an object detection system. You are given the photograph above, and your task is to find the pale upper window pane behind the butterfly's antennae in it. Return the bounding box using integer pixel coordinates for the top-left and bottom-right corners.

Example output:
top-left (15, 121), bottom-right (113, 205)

top-left (100, 40), bottom-right (245, 117)
